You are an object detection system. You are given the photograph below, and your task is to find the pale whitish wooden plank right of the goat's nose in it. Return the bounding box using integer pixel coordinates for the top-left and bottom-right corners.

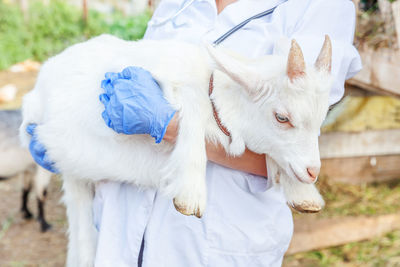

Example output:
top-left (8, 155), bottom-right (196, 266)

top-left (319, 129), bottom-right (400, 159)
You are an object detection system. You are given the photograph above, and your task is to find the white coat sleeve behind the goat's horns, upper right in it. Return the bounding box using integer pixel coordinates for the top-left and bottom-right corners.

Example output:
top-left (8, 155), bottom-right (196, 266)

top-left (288, 0), bottom-right (362, 105)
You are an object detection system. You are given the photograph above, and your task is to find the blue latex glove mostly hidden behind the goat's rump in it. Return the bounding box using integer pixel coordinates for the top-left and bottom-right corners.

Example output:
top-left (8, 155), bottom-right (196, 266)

top-left (26, 124), bottom-right (59, 173)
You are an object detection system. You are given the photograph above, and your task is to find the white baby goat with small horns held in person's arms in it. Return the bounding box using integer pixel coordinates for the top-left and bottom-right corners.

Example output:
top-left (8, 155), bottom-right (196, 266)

top-left (20, 35), bottom-right (331, 266)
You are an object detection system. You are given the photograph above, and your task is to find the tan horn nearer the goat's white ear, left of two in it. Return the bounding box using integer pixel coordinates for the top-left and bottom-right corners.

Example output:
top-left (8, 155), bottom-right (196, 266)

top-left (286, 39), bottom-right (306, 82)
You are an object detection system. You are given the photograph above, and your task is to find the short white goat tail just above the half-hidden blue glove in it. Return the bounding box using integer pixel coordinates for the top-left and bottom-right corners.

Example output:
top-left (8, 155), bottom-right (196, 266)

top-left (19, 86), bottom-right (44, 147)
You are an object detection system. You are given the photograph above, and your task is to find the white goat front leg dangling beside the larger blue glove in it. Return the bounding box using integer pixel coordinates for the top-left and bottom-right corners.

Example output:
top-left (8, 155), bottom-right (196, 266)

top-left (162, 105), bottom-right (207, 218)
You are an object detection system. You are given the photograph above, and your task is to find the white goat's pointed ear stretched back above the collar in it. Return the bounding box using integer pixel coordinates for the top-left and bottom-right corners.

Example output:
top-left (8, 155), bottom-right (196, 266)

top-left (206, 45), bottom-right (260, 93)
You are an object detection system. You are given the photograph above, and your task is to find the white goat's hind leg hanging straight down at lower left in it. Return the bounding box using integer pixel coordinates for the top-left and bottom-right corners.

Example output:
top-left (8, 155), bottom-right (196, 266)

top-left (63, 176), bottom-right (97, 267)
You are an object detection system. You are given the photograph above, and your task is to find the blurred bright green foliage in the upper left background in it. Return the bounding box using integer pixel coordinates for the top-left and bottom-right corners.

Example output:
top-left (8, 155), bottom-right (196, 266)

top-left (0, 0), bottom-right (151, 69)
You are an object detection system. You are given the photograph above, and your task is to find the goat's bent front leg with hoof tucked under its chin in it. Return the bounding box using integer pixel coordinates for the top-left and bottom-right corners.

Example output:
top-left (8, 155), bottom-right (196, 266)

top-left (267, 157), bottom-right (325, 213)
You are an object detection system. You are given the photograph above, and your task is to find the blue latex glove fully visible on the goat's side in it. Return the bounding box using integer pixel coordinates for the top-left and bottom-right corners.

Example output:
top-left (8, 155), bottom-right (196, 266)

top-left (100, 67), bottom-right (176, 143)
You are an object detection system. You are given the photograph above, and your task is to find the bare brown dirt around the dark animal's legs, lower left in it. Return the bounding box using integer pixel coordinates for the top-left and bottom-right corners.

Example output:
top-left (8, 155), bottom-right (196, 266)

top-left (0, 177), bottom-right (67, 267)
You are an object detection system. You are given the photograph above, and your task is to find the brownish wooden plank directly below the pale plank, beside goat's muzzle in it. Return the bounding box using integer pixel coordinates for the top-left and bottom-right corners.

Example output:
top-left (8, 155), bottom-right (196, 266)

top-left (320, 155), bottom-right (400, 184)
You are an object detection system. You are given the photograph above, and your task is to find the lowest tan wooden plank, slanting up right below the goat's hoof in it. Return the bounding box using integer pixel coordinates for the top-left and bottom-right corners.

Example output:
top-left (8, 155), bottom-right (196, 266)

top-left (286, 214), bottom-right (400, 255)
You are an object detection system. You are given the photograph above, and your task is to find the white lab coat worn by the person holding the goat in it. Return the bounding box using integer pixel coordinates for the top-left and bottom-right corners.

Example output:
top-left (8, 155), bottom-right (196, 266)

top-left (93, 0), bottom-right (361, 267)
